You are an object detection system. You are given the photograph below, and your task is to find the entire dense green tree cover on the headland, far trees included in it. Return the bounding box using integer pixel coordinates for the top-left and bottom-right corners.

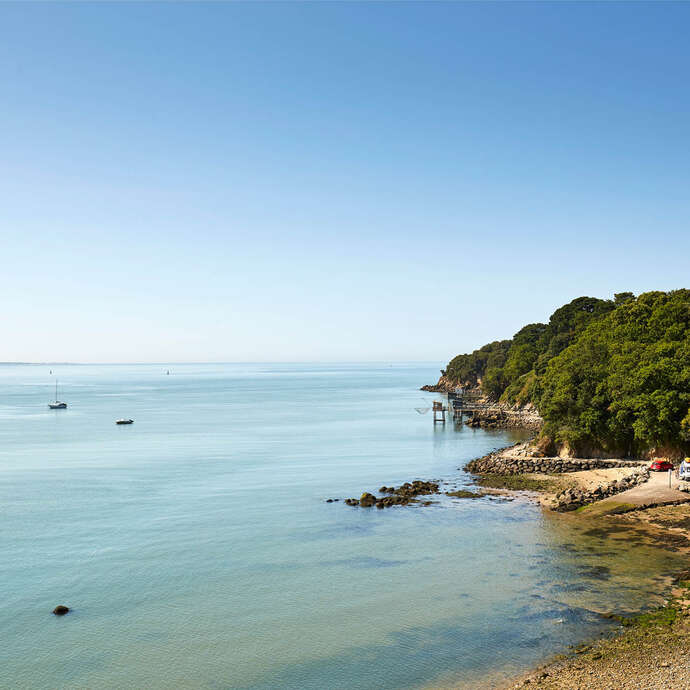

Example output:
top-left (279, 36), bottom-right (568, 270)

top-left (442, 290), bottom-right (690, 456)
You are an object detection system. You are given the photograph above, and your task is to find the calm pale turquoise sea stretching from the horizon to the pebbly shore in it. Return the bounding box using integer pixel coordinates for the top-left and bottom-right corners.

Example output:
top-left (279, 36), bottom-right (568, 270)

top-left (0, 364), bottom-right (684, 690)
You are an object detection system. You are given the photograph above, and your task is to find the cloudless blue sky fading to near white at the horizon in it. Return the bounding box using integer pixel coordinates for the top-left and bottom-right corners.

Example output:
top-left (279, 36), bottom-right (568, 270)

top-left (0, 3), bottom-right (690, 362)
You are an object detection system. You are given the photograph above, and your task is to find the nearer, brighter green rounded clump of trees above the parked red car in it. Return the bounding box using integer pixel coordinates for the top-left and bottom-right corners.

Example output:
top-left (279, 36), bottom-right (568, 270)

top-left (538, 290), bottom-right (690, 455)
